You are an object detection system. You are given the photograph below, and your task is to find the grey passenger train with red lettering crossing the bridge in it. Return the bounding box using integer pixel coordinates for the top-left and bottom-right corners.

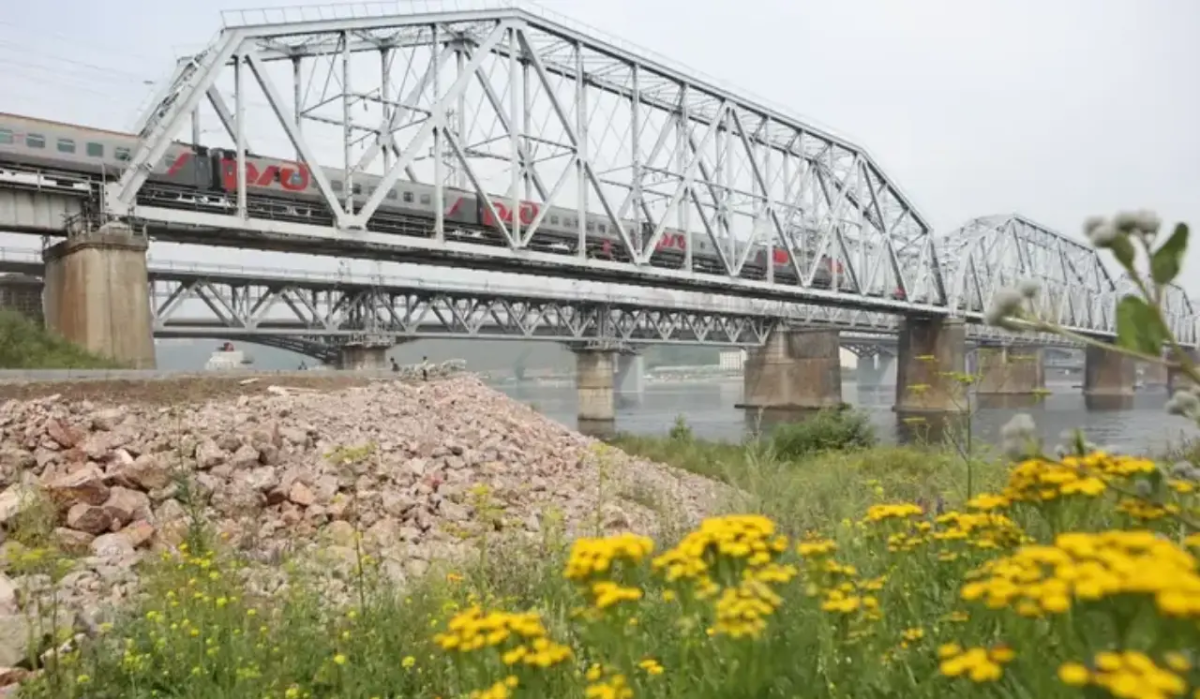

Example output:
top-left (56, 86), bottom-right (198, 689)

top-left (0, 114), bottom-right (847, 288)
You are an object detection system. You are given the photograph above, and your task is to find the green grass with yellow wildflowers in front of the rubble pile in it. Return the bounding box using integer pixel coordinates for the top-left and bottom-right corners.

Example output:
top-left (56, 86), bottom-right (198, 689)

top-left (4, 415), bottom-right (1200, 699)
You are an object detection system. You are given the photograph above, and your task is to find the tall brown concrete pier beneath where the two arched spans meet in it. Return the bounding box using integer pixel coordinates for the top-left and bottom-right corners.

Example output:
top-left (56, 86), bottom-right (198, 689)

top-left (895, 317), bottom-right (966, 414)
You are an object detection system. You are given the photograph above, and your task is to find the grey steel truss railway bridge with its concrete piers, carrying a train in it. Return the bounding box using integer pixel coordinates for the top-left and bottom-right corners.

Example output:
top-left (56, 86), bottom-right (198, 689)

top-left (0, 1), bottom-right (1196, 429)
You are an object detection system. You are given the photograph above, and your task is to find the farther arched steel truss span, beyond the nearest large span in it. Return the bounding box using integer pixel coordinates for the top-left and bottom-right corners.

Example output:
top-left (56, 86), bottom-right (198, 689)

top-left (938, 215), bottom-right (1196, 346)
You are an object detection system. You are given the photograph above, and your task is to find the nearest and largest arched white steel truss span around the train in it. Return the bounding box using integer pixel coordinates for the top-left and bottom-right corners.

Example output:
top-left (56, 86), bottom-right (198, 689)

top-left (104, 2), bottom-right (948, 316)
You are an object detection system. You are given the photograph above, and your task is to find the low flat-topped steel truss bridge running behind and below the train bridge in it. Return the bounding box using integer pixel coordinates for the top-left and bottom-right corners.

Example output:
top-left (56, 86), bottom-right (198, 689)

top-left (0, 249), bottom-right (1147, 362)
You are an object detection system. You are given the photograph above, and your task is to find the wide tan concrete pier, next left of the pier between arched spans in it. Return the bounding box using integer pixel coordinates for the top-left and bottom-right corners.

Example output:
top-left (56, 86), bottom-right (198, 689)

top-left (734, 329), bottom-right (841, 411)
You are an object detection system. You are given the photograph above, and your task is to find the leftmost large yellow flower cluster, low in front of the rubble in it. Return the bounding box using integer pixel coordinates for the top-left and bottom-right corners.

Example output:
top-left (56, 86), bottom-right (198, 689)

top-left (433, 605), bottom-right (571, 672)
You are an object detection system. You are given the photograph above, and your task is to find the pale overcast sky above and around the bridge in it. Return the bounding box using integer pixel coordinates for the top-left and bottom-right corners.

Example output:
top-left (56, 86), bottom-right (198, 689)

top-left (0, 0), bottom-right (1200, 294)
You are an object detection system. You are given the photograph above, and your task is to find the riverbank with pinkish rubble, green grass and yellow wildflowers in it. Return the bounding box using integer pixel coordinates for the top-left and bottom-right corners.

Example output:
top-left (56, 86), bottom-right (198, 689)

top-left (0, 378), bottom-right (1200, 699)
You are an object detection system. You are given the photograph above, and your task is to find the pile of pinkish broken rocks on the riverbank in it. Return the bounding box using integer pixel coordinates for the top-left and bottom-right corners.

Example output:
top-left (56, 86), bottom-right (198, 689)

top-left (0, 375), bottom-right (721, 668)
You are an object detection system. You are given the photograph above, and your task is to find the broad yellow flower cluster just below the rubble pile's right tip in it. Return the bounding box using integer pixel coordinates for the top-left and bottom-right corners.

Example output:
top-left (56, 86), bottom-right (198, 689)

top-left (652, 515), bottom-right (787, 595)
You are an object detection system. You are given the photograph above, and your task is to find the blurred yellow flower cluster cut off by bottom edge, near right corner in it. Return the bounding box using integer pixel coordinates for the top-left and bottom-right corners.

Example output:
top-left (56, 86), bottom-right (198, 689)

top-left (1058, 651), bottom-right (1192, 699)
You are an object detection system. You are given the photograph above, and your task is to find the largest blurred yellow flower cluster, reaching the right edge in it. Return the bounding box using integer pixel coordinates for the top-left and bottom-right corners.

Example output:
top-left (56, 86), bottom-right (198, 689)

top-left (961, 531), bottom-right (1200, 619)
